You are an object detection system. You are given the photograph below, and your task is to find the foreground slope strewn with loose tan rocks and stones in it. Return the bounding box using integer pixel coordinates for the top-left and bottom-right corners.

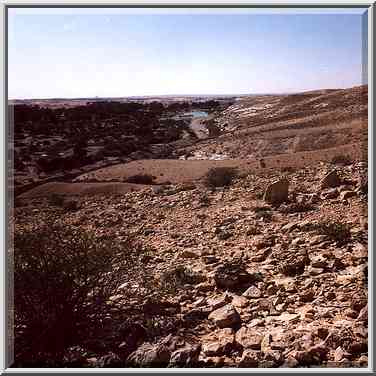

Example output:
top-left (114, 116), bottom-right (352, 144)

top-left (14, 162), bottom-right (368, 367)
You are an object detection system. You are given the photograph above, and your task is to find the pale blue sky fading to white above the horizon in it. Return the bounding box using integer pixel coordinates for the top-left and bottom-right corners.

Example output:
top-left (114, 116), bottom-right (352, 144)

top-left (8, 9), bottom-right (364, 99)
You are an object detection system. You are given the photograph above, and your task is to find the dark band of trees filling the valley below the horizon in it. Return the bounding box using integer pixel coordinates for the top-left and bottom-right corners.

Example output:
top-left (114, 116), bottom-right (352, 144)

top-left (8, 101), bottom-right (223, 173)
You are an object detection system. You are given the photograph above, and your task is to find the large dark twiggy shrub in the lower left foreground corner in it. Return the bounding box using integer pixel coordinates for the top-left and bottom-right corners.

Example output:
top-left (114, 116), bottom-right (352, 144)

top-left (13, 220), bottom-right (137, 364)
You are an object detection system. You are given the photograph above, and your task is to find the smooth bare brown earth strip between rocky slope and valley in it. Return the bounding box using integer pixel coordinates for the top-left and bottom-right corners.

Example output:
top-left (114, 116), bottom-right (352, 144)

top-left (20, 144), bottom-right (364, 197)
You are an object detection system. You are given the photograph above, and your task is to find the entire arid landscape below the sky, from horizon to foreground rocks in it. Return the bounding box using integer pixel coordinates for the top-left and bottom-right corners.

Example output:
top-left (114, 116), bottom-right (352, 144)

top-left (10, 86), bottom-right (368, 368)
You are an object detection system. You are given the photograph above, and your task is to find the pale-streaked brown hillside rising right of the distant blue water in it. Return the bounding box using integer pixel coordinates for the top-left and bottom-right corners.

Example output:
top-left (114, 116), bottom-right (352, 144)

top-left (181, 86), bottom-right (368, 159)
